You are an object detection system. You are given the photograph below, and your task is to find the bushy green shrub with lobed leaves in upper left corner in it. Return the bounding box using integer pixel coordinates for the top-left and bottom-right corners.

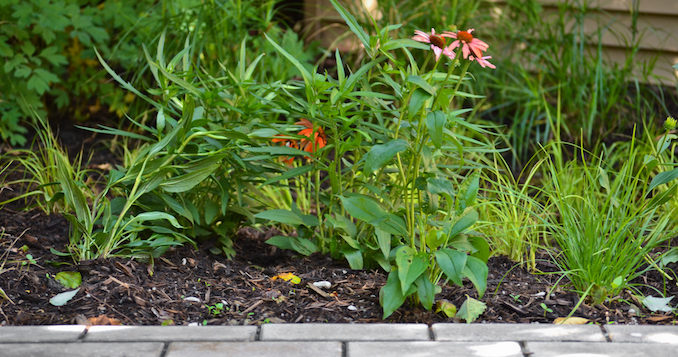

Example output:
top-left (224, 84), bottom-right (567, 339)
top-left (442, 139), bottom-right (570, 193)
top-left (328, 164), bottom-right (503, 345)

top-left (0, 0), bottom-right (160, 145)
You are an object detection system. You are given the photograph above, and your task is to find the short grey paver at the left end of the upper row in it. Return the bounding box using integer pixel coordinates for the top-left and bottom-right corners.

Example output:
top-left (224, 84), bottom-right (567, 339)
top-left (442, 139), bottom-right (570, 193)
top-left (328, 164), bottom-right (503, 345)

top-left (0, 325), bottom-right (85, 343)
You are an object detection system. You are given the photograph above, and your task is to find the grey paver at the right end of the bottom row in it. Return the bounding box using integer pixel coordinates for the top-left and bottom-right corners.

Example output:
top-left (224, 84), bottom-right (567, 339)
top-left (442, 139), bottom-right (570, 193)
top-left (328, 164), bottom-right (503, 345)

top-left (525, 342), bottom-right (678, 357)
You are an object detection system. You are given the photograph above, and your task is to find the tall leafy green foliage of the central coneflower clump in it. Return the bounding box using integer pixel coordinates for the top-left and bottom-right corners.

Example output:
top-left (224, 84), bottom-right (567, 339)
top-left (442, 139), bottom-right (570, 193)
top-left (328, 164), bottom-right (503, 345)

top-left (250, 1), bottom-right (494, 317)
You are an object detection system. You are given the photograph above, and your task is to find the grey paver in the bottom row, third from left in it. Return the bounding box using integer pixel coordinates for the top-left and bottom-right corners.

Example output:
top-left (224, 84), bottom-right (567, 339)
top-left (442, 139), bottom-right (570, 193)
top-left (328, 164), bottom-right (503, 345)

top-left (346, 341), bottom-right (523, 357)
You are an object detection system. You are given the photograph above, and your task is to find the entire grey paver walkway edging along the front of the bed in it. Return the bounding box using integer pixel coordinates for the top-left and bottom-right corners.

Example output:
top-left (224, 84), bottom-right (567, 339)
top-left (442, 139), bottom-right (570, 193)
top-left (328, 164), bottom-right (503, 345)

top-left (0, 323), bottom-right (678, 357)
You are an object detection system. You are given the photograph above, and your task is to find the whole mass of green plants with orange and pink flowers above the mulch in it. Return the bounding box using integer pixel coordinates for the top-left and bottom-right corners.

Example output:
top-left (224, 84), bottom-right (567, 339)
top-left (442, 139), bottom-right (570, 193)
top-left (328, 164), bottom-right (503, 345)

top-left (5, 0), bottom-right (678, 321)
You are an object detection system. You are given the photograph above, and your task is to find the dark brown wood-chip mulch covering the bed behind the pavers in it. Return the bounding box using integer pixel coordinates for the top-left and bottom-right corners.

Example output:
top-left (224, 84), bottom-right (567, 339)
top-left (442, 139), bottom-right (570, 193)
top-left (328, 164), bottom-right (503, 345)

top-left (0, 121), bottom-right (678, 325)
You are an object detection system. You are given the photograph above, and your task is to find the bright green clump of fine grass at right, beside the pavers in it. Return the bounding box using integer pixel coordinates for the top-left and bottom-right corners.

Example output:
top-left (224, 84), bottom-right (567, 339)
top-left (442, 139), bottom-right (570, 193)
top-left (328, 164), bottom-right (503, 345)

top-left (545, 135), bottom-right (678, 304)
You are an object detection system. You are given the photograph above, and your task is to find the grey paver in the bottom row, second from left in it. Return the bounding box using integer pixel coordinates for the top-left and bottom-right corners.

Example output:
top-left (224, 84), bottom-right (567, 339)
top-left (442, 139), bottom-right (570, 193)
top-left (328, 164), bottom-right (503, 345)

top-left (165, 341), bottom-right (342, 357)
